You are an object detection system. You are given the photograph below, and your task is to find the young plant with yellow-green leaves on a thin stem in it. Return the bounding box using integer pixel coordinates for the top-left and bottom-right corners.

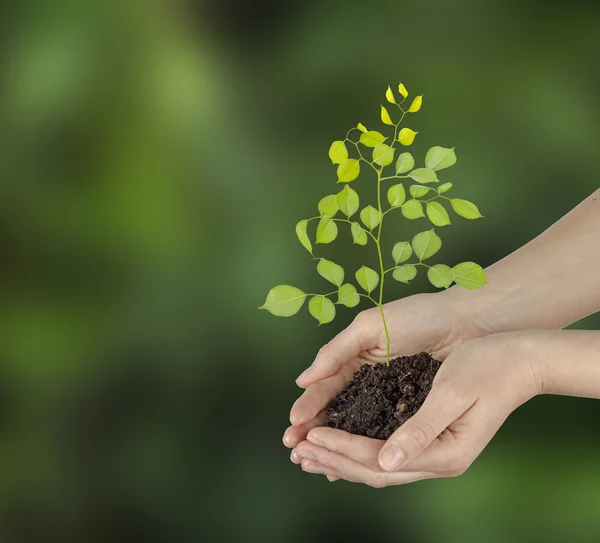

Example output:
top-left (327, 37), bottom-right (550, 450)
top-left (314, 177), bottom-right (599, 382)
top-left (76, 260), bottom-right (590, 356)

top-left (259, 84), bottom-right (487, 365)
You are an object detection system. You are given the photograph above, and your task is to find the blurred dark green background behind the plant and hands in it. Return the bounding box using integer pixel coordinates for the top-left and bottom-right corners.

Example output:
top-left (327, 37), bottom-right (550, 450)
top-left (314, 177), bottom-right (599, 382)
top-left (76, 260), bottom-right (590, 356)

top-left (0, 0), bottom-right (600, 543)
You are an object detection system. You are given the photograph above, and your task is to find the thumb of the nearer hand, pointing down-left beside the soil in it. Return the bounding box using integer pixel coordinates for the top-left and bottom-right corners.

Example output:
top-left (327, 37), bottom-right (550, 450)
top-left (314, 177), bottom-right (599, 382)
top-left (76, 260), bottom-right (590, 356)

top-left (379, 385), bottom-right (467, 471)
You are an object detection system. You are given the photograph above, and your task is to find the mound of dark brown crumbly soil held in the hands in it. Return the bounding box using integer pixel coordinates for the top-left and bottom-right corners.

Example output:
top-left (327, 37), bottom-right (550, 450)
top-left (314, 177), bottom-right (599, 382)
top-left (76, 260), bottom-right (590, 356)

top-left (326, 353), bottom-right (441, 439)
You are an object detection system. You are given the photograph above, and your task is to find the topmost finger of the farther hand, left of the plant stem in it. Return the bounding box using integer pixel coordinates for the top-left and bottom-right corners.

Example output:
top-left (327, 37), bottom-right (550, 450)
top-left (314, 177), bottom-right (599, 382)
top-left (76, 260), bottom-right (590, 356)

top-left (296, 310), bottom-right (381, 388)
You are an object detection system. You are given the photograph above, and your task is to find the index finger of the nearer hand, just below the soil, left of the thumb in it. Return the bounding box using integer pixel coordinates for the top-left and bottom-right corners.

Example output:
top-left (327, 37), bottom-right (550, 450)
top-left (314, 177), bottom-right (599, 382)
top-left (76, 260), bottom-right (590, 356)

top-left (306, 428), bottom-right (384, 470)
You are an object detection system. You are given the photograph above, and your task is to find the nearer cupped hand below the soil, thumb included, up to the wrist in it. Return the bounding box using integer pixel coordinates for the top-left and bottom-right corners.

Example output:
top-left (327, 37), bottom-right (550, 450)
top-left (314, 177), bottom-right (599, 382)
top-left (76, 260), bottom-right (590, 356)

top-left (291, 331), bottom-right (545, 488)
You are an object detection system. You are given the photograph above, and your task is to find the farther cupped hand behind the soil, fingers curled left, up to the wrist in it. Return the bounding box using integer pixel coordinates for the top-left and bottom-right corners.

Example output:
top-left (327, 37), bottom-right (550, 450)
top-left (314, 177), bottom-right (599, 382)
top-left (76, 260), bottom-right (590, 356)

top-left (283, 289), bottom-right (488, 448)
